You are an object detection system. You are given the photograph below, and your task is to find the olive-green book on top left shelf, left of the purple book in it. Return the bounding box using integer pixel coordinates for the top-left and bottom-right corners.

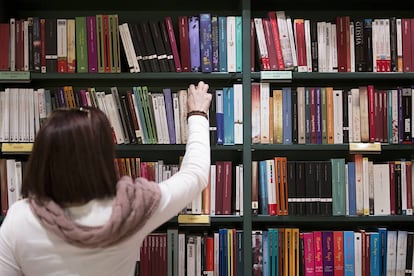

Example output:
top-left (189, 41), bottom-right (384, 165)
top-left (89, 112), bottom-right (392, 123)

top-left (75, 16), bottom-right (88, 73)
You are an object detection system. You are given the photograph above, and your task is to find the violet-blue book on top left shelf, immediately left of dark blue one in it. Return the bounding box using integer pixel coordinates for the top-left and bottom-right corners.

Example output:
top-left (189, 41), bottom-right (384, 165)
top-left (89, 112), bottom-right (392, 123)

top-left (188, 16), bottom-right (201, 72)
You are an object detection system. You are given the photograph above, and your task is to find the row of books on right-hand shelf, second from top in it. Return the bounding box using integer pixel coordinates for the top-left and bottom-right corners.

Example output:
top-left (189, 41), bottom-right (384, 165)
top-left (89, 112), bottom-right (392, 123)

top-left (251, 82), bottom-right (414, 144)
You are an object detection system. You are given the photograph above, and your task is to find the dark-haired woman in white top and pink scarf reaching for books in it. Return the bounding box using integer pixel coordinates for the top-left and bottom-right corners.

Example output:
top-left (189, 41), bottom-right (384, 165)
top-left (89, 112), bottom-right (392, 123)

top-left (0, 82), bottom-right (211, 276)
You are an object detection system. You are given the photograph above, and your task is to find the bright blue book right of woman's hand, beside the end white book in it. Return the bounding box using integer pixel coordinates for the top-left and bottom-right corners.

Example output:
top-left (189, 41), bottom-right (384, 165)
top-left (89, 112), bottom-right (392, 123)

top-left (223, 87), bottom-right (234, 145)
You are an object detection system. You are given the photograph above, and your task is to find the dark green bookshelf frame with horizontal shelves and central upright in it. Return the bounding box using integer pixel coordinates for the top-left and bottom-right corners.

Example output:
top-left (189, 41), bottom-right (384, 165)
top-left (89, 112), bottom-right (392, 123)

top-left (0, 0), bottom-right (414, 275)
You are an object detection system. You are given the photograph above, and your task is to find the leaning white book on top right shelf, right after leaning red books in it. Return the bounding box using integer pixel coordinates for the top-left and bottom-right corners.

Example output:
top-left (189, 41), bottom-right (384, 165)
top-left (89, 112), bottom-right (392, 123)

top-left (276, 11), bottom-right (294, 70)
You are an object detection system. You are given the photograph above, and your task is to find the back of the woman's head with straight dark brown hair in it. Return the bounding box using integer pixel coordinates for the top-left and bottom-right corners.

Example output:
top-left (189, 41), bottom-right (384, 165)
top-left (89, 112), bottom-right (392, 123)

top-left (22, 108), bottom-right (116, 205)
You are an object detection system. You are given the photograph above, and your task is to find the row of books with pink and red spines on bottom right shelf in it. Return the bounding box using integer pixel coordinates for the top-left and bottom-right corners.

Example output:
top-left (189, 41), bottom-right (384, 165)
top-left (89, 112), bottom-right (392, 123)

top-left (252, 228), bottom-right (414, 276)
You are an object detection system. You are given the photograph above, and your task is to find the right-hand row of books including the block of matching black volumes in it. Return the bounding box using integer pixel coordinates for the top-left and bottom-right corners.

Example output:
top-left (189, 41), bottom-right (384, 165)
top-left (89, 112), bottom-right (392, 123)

top-left (252, 154), bottom-right (414, 216)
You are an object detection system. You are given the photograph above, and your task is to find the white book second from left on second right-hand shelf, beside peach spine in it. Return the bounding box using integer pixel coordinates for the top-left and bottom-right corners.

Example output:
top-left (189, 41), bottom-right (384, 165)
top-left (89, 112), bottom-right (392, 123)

top-left (260, 82), bottom-right (270, 144)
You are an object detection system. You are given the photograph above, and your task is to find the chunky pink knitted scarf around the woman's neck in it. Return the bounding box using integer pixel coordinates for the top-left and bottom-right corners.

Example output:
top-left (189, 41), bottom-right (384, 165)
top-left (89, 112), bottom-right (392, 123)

top-left (29, 176), bottom-right (161, 248)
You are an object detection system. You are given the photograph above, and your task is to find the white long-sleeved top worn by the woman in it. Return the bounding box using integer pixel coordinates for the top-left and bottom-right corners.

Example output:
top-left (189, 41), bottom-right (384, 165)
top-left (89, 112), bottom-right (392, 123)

top-left (0, 116), bottom-right (210, 276)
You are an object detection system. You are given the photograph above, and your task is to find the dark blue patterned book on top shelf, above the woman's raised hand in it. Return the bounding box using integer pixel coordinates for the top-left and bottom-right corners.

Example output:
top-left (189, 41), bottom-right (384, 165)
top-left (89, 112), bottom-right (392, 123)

top-left (200, 13), bottom-right (213, 72)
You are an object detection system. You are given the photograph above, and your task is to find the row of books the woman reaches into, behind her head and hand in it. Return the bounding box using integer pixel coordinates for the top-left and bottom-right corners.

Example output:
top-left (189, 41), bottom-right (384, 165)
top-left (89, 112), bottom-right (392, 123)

top-left (0, 84), bottom-right (243, 145)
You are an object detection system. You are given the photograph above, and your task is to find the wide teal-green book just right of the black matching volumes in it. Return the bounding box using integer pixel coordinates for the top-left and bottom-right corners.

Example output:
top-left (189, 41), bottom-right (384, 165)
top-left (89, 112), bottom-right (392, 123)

top-left (331, 158), bottom-right (346, 216)
